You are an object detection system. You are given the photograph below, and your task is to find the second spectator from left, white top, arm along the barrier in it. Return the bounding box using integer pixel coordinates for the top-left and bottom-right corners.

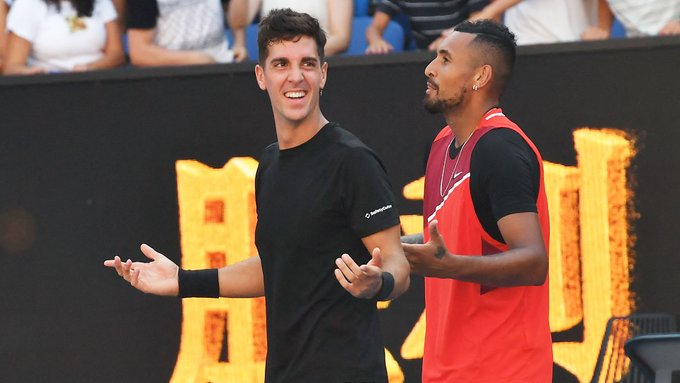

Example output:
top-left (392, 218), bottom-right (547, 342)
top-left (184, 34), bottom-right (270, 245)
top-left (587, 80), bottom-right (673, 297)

top-left (126, 0), bottom-right (233, 66)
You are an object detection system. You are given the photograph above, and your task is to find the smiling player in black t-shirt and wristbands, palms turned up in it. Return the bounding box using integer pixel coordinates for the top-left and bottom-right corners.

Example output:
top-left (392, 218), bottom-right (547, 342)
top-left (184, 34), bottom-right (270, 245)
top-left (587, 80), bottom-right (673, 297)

top-left (104, 10), bottom-right (409, 383)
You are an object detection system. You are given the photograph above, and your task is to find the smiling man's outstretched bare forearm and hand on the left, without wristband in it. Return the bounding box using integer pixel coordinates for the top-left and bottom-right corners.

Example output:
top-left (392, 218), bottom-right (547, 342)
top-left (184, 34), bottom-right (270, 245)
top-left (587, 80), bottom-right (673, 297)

top-left (104, 245), bottom-right (264, 298)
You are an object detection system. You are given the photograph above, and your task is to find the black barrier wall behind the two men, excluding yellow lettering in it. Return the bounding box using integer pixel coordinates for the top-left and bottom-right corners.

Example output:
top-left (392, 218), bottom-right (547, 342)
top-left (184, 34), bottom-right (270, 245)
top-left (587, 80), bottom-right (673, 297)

top-left (0, 38), bottom-right (680, 382)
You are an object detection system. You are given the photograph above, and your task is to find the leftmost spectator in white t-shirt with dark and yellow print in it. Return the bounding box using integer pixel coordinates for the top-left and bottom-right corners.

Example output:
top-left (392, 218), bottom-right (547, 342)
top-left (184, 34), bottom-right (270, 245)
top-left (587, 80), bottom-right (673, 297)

top-left (4, 0), bottom-right (125, 74)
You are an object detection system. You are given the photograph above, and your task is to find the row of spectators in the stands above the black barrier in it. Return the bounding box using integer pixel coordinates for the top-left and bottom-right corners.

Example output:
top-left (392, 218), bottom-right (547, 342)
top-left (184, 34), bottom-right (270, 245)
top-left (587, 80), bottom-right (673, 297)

top-left (0, 0), bottom-right (680, 75)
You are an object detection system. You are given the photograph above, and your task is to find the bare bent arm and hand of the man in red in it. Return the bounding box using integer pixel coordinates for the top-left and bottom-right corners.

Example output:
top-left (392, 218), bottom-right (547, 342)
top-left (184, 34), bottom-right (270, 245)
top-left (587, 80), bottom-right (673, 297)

top-left (403, 213), bottom-right (548, 287)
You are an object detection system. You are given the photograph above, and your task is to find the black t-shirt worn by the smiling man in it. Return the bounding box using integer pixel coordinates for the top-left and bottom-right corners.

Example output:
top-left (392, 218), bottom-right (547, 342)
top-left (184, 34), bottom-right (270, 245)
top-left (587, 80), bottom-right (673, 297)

top-left (255, 123), bottom-right (399, 383)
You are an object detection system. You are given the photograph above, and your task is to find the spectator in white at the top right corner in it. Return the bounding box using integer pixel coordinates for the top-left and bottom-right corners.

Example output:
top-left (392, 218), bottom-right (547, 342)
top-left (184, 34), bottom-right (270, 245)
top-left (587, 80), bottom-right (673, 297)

top-left (584, 0), bottom-right (680, 38)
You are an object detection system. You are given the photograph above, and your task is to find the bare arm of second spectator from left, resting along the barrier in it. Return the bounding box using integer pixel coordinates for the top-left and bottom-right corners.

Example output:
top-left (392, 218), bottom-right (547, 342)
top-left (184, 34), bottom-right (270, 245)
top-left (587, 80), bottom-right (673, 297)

top-left (128, 29), bottom-right (215, 66)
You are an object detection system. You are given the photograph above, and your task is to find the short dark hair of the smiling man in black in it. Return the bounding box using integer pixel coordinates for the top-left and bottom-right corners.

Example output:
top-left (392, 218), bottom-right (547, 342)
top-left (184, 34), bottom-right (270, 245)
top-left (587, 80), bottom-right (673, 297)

top-left (257, 8), bottom-right (326, 64)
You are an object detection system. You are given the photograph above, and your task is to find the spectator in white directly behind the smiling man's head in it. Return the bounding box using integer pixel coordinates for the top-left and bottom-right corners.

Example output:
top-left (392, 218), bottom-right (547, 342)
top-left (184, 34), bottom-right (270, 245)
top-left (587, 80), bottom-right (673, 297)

top-left (228, 0), bottom-right (354, 56)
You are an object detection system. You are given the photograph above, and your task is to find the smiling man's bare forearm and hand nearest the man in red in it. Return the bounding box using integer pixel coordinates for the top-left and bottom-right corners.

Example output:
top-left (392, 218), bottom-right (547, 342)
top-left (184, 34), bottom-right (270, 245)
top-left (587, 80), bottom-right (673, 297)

top-left (335, 225), bottom-right (410, 299)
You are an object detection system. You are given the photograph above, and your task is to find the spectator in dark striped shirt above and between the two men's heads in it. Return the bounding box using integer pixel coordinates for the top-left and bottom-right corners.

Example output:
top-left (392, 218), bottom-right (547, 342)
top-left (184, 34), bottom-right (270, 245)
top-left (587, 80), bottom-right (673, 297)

top-left (366, 0), bottom-right (516, 54)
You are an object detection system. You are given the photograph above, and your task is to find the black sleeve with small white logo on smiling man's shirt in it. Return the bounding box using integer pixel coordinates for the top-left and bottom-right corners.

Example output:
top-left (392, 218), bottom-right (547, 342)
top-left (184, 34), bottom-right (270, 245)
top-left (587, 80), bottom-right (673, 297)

top-left (341, 148), bottom-right (399, 238)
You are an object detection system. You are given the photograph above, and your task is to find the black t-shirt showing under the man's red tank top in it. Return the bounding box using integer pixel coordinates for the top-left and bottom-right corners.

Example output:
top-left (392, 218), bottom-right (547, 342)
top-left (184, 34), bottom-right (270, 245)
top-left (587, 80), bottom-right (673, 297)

top-left (450, 128), bottom-right (540, 242)
